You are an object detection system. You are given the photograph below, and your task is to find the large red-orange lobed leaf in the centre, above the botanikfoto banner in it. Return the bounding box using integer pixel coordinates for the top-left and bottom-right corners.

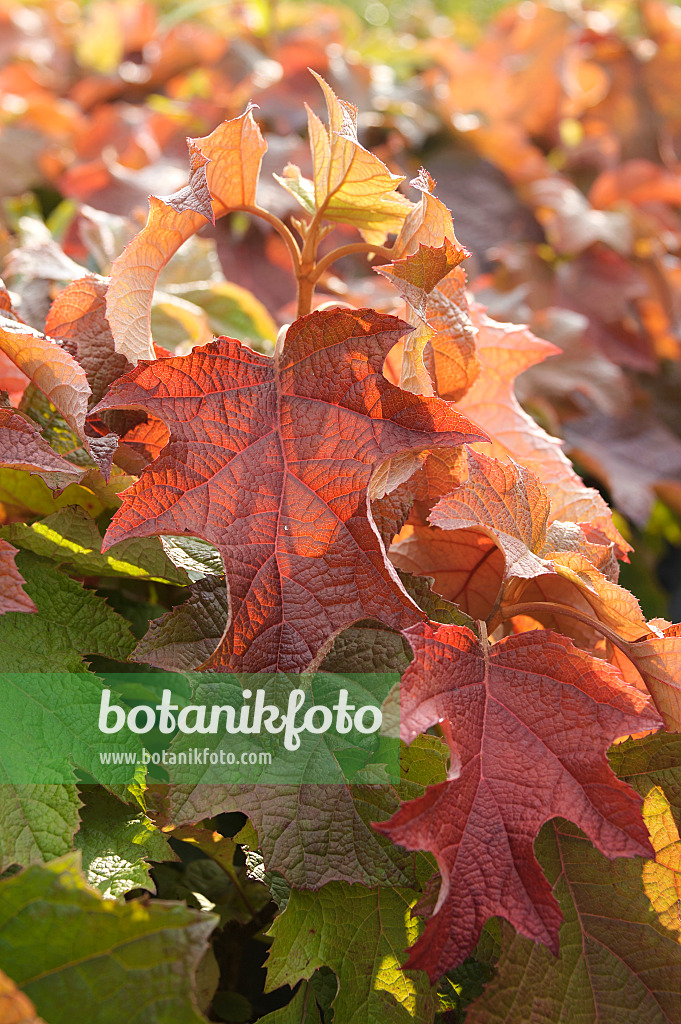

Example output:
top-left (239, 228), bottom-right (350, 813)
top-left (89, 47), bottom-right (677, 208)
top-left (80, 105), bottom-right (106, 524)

top-left (97, 309), bottom-right (484, 672)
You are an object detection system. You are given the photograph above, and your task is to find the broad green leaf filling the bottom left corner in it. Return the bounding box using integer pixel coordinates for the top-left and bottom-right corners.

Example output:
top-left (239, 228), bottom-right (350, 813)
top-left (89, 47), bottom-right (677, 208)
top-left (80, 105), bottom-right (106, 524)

top-left (0, 855), bottom-right (216, 1024)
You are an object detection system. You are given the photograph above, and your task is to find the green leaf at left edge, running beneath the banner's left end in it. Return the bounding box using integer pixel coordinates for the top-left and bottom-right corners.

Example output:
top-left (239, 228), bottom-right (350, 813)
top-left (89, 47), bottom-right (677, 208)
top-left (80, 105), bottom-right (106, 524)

top-left (0, 552), bottom-right (136, 866)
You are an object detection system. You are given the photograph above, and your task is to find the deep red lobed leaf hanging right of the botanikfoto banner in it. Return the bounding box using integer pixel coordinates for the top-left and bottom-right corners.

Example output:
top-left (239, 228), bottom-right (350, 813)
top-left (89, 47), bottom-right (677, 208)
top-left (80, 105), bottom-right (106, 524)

top-left (377, 624), bottom-right (659, 979)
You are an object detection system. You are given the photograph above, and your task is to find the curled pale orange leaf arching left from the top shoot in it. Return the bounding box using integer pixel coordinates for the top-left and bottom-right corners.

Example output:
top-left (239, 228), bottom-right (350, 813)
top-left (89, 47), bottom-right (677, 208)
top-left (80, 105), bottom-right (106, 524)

top-left (107, 109), bottom-right (267, 364)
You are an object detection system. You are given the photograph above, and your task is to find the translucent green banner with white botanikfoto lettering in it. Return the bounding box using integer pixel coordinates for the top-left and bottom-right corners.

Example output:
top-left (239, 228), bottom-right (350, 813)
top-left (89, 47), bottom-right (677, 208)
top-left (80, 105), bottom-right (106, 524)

top-left (0, 672), bottom-right (399, 785)
